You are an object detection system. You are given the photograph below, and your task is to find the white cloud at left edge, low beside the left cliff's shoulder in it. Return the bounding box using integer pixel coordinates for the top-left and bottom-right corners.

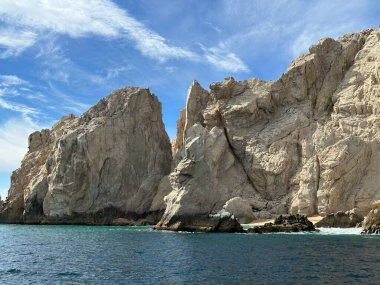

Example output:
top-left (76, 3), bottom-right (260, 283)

top-left (0, 116), bottom-right (42, 172)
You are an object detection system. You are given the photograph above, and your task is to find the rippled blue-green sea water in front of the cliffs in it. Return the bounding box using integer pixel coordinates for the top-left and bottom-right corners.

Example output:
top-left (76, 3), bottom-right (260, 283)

top-left (0, 225), bottom-right (380, 284)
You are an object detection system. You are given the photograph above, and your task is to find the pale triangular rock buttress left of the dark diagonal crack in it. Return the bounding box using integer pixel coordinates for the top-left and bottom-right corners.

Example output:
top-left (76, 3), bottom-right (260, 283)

top-left (156, 123), bottom-right (260, 230)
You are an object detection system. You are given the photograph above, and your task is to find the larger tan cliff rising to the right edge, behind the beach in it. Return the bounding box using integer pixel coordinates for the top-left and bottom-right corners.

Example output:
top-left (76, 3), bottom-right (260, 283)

top-left (158, 29), bottom-right (380, 228)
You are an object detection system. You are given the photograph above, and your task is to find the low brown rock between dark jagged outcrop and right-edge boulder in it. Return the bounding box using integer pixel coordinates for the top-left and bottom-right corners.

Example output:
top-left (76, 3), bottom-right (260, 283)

top-left (315, 207), bottom-right (364, 228)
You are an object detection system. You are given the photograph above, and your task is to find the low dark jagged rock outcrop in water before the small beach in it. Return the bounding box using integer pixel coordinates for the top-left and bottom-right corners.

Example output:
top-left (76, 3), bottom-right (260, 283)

top-left (248, 214), bottom-right (316, 234)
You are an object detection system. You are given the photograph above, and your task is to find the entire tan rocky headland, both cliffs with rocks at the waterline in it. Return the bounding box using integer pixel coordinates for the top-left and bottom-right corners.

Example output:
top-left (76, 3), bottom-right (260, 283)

top-left (0, 28), bottom-right (380, 233)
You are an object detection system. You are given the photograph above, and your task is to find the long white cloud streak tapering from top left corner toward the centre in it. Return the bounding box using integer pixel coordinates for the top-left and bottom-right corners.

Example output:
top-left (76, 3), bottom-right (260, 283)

top-left (0, 0), bottom-right (248, 73)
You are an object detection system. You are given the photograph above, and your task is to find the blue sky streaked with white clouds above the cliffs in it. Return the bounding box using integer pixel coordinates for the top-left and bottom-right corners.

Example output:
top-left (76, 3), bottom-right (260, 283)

top-left (0, 0), bottom-right (380, 198)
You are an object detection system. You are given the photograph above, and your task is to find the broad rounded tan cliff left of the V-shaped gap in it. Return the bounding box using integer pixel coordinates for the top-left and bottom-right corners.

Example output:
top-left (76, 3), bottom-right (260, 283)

top-left (0, 87), bottom-right (172, 224)
